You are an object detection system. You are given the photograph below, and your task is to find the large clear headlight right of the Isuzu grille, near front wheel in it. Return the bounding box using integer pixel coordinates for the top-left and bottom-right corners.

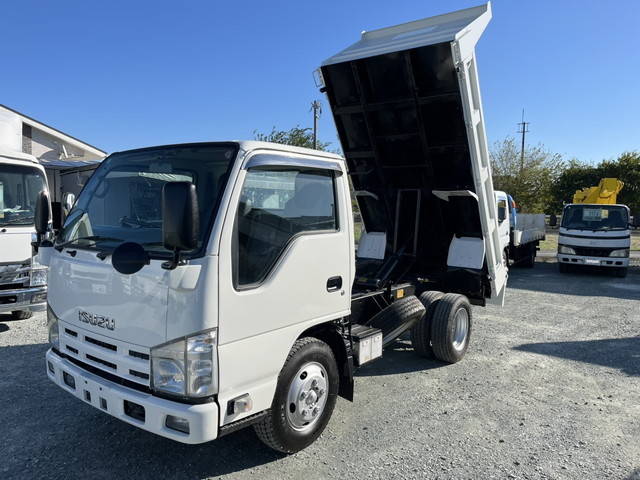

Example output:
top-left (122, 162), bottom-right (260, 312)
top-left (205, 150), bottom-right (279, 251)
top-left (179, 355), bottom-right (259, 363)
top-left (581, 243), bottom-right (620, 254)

top-left (151, 328), bottom-right (218, 397)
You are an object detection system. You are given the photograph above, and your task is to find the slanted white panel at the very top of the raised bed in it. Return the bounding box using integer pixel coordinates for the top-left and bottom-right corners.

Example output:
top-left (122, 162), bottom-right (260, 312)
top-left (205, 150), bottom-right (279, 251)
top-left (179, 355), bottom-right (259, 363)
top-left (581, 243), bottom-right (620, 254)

top-left (322, 2), bottom-right (491, 65)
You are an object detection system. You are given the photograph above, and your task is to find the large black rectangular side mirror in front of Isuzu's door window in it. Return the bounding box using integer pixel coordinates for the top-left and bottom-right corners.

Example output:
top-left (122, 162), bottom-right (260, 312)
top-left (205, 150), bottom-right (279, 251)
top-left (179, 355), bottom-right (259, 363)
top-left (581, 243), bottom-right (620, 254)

top-left (162, 182), bottom-right (200, 270)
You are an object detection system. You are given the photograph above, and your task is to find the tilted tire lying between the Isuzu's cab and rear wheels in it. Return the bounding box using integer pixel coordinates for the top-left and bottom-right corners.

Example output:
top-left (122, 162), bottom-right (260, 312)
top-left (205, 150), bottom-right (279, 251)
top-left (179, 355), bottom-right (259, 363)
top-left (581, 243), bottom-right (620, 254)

top-left (367, 295), bottom-right (426, 347)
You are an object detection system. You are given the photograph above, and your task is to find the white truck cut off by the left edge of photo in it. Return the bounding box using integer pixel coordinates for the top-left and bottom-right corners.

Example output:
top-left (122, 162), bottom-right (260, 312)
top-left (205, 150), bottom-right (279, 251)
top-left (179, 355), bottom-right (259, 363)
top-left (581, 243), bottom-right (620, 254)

top-left (0, 149), bottom-right (47, 320)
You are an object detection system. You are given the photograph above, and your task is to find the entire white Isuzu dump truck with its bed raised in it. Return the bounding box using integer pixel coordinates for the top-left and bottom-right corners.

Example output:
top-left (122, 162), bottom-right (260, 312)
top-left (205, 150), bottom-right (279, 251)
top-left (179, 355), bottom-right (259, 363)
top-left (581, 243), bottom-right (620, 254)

top-left (37, 5), bottom-right (507, 452)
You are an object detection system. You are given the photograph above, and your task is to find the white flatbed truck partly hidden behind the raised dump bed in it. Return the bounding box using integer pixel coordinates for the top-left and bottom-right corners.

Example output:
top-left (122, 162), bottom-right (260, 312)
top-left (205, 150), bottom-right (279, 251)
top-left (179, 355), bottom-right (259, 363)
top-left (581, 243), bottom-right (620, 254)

top-left (496, 190), bottom-right (546, 268)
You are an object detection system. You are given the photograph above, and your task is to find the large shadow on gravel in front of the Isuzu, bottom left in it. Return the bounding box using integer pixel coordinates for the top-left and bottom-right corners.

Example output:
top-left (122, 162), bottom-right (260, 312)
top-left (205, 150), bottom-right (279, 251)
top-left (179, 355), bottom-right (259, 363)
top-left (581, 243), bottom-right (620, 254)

top-left (0, 344), bottom-right (284, 478)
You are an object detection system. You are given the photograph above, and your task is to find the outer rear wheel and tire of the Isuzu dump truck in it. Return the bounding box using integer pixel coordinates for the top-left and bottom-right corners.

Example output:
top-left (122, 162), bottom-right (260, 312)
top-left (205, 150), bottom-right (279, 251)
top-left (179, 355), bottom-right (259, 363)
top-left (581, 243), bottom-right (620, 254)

top-left (431, 293), bottom-right (471, 363)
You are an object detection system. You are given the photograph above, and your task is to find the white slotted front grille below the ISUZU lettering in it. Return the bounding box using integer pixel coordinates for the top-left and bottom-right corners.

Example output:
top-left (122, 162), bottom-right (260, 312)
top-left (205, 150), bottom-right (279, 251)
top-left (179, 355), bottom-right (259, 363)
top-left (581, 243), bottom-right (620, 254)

top-left (60, 321), bottom-right (151, 387)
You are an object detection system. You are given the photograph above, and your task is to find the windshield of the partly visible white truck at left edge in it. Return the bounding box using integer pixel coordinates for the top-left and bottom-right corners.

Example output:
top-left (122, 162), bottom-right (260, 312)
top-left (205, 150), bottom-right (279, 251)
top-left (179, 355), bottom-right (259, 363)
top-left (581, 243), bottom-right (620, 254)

top-left (0, 164), bottom-right (47, 227)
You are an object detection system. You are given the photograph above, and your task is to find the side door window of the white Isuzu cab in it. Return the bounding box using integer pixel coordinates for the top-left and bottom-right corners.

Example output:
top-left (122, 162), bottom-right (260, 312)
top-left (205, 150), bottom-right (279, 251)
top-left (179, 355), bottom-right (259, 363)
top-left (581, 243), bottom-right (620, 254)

top-left (233, 167), bottom-right (338, 288)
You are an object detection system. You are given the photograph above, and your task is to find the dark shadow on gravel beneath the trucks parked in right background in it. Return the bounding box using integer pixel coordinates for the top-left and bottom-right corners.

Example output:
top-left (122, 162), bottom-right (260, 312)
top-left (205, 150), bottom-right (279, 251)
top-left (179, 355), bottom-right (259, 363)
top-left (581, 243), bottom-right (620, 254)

top-left (507, 262), bottom-right (640, 300)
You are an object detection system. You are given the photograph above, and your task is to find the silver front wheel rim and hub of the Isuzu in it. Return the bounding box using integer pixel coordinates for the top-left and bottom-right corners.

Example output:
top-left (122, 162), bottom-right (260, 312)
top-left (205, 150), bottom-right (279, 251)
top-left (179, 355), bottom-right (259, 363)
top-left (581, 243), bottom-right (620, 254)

top-left (286, 362), bottom-right (327, 431)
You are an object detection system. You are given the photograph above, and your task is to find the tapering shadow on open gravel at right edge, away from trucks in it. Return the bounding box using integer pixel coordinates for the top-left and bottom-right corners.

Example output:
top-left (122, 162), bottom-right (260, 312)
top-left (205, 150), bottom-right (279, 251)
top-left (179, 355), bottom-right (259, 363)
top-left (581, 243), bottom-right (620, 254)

top-left (514, 336), bottom-right (640, 376)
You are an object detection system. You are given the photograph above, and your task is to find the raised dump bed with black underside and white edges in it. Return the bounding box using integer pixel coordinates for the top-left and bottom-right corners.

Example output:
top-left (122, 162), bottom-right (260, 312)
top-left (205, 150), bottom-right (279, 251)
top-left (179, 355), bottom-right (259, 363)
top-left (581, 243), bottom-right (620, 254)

top-left (320, 4), bottom-right (506, 303)
